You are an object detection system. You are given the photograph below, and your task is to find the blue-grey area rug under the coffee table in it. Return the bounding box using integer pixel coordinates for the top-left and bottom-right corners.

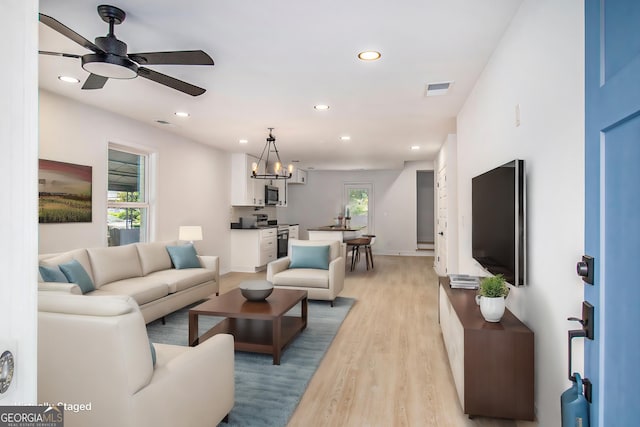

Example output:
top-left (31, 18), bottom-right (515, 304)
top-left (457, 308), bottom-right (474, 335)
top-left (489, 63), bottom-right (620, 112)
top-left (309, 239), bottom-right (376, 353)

top-left (147, 297), bottom-right (355, 427)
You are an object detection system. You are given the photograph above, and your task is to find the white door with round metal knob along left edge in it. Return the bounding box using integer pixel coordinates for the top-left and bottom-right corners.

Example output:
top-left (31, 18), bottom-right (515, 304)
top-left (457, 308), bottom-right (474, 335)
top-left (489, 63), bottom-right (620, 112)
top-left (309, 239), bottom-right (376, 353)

top-left (0, 0), bottom-right (38, 405)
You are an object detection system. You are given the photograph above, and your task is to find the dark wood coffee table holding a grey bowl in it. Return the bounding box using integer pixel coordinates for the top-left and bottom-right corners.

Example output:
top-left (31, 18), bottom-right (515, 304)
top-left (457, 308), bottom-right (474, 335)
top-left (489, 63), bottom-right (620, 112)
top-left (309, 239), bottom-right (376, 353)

top-left (189, 288), bottom-right (307, 365)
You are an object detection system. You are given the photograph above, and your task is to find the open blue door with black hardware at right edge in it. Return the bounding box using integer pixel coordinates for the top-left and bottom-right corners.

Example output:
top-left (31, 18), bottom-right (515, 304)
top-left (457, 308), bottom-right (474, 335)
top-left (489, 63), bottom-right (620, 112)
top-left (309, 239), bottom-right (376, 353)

top-left (584, 0), bottom-right (640, 427)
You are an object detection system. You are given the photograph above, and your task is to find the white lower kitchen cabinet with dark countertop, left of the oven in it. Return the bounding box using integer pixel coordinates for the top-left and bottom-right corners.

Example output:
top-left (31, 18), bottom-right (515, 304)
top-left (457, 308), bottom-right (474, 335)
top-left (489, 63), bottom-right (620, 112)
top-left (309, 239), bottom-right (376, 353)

top-left (231, 227), bottom-right (278, 273)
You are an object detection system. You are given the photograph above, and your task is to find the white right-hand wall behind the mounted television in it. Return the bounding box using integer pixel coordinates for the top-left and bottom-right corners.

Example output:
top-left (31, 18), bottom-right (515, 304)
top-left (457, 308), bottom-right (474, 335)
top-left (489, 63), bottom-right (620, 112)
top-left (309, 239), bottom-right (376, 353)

top-left (458, 0), bottom-right (584, 426)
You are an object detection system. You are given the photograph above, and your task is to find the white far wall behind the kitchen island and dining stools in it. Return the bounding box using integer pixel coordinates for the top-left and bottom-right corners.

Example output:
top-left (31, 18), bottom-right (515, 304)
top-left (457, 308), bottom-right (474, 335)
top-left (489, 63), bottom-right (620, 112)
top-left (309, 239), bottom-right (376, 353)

top-left (278, 161), bottom-right (433, 255)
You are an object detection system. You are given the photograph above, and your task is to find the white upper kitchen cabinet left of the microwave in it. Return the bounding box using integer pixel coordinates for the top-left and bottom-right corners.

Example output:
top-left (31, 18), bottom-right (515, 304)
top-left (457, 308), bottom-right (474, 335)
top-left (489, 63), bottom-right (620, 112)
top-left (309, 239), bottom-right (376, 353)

top-left (231, 153), bottom-right (265, 206)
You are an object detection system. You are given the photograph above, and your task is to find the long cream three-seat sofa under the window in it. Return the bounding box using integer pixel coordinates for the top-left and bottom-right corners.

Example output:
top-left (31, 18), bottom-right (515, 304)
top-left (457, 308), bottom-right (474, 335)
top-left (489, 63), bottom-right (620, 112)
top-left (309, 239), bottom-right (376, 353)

top-left (38, 242), bottom-right (220, 323)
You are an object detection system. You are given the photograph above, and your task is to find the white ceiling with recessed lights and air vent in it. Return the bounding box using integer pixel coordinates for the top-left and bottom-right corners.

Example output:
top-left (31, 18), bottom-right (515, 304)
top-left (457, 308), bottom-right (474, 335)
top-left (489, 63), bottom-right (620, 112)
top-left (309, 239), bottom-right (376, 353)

top-left (39, 0), bottom-right (521, 169)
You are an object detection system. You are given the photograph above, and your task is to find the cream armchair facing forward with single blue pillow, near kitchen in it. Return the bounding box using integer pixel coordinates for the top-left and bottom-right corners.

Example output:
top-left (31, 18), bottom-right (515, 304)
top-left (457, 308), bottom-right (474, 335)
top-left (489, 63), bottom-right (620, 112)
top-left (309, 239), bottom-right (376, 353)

top-left (267, 239), bottom-right (346, 306)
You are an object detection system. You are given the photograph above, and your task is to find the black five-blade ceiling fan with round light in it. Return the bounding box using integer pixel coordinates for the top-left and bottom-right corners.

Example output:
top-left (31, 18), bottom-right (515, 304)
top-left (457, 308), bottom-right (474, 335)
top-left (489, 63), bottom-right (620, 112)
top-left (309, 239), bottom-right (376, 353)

top-left (39, 5), bottom-right (213, 96)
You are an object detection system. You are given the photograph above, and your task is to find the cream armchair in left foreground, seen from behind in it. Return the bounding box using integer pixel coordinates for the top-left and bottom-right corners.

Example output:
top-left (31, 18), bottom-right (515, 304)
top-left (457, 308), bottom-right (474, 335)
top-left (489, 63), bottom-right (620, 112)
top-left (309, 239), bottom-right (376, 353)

top-left (38, 292), bottom-right (235, 427)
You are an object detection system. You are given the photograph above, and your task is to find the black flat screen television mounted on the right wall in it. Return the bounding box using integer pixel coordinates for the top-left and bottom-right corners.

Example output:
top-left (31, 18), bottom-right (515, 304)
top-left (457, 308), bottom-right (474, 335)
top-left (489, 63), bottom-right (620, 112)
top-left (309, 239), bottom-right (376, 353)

top-left (471, 160), bottom-right (527, 286)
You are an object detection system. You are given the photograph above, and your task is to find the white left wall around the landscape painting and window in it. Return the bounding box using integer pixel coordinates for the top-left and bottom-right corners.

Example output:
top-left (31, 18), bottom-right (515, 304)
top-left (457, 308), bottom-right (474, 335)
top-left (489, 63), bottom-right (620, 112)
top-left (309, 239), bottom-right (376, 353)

top-left (39, 91), bottom-right (230, 272)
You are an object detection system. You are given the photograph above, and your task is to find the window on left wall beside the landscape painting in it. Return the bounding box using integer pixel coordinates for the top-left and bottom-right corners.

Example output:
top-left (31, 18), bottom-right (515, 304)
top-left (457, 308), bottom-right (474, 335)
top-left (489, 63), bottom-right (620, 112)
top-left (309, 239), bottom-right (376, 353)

top-left (107, 145), bottom-right (149, 246)
